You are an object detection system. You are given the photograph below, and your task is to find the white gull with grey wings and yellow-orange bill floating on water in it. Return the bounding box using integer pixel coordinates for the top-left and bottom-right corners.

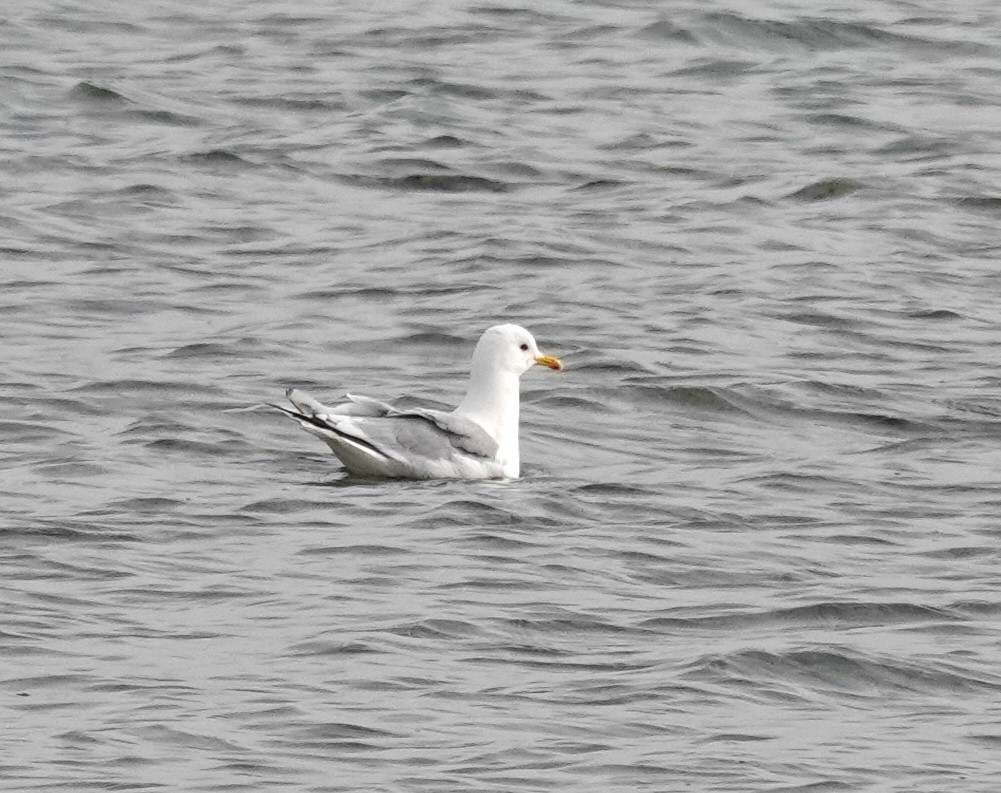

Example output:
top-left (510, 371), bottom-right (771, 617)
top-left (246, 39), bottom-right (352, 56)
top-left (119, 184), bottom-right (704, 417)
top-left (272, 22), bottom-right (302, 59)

top-left (270, 324), bottom-right (563, 480)
